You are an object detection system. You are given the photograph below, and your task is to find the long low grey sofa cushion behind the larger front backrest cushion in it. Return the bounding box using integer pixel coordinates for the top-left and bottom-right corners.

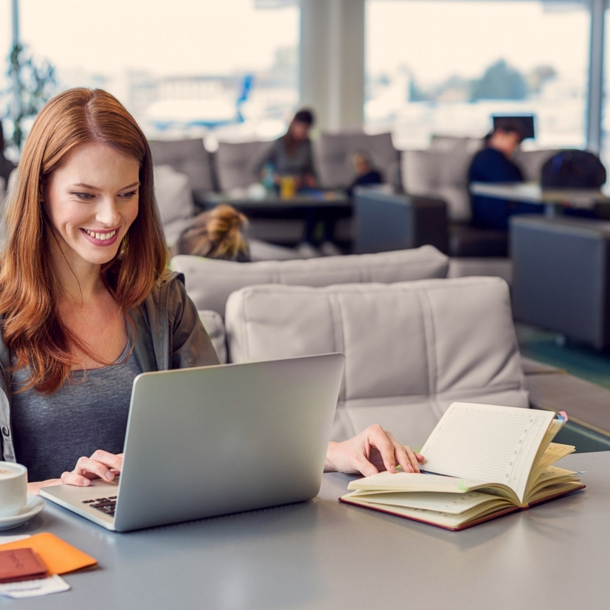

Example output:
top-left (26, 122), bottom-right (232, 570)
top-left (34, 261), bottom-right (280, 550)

top-left (170, 246), bottom-right (449, 315)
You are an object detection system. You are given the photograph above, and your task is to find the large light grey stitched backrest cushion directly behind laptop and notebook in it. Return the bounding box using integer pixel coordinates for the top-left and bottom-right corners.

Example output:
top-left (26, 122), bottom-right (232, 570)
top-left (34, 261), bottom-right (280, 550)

top-left (226, 278), bottom-right (528, 446)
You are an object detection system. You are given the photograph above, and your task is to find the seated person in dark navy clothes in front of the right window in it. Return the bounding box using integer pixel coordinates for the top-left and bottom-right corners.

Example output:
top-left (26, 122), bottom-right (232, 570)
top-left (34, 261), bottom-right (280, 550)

top-left (468, 120), bottom-right (543, 231)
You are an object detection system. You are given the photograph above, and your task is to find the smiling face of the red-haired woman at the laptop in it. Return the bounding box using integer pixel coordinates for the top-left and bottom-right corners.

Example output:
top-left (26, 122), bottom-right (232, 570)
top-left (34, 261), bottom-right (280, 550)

top-left (44, 142), bottom-right (140, 266)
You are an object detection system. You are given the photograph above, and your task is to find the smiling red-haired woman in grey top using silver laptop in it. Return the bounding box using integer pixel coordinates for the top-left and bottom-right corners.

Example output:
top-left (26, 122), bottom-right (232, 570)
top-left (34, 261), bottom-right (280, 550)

top-left (0, 88), bottom-right (423, 492)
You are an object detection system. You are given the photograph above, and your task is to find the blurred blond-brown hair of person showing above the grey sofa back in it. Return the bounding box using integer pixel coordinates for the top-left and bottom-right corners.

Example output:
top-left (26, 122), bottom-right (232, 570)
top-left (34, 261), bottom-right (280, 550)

top-left (172, 205), bottom-right (250, 263)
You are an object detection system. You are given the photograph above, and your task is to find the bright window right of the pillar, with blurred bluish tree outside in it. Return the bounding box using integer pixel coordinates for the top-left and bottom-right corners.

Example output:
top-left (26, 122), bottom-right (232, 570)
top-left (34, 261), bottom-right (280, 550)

top-left (365, 0), bottom-right (589, 148)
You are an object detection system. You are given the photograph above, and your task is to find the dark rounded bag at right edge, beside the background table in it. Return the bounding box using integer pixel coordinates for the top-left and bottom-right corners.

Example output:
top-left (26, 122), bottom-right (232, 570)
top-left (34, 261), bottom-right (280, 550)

top-left (540, 149), bottom-right (606, 189)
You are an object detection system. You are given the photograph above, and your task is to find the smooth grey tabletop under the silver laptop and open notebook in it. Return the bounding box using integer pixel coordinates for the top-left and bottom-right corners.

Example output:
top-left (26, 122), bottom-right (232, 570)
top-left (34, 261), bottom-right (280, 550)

top-left (0, 452), bottom-right (610, 610)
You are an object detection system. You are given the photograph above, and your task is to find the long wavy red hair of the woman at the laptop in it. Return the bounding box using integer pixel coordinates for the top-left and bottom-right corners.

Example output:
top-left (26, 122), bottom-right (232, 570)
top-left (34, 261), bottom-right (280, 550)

top-left (0, 88), bottom-right (167, 394)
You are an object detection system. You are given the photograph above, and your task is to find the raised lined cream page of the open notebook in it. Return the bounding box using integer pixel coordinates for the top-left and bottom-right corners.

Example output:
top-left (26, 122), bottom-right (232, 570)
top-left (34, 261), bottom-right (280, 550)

top-left (421, 402), bottom-right (555, 501)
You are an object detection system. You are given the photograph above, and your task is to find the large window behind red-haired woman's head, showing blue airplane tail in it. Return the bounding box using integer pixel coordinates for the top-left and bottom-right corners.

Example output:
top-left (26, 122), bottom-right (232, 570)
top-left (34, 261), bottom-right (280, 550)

top-left (0, 0), bottom-right (299, 147)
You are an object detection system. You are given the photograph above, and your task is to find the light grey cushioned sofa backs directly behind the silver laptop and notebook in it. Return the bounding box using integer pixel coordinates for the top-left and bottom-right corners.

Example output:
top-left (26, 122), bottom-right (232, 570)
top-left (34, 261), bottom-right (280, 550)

top-left (172, 246), bottom-right (528, 445)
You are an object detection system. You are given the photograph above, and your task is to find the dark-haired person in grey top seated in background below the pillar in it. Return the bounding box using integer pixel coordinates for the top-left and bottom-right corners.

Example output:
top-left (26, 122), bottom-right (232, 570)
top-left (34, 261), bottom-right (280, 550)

top-left (257, 110), bottom-right (316, 189)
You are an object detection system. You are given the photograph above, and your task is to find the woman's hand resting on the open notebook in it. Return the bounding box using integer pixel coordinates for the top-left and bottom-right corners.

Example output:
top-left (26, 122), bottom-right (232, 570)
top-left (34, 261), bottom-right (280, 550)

top-left (324, 424), bottom-right (425, 477)
